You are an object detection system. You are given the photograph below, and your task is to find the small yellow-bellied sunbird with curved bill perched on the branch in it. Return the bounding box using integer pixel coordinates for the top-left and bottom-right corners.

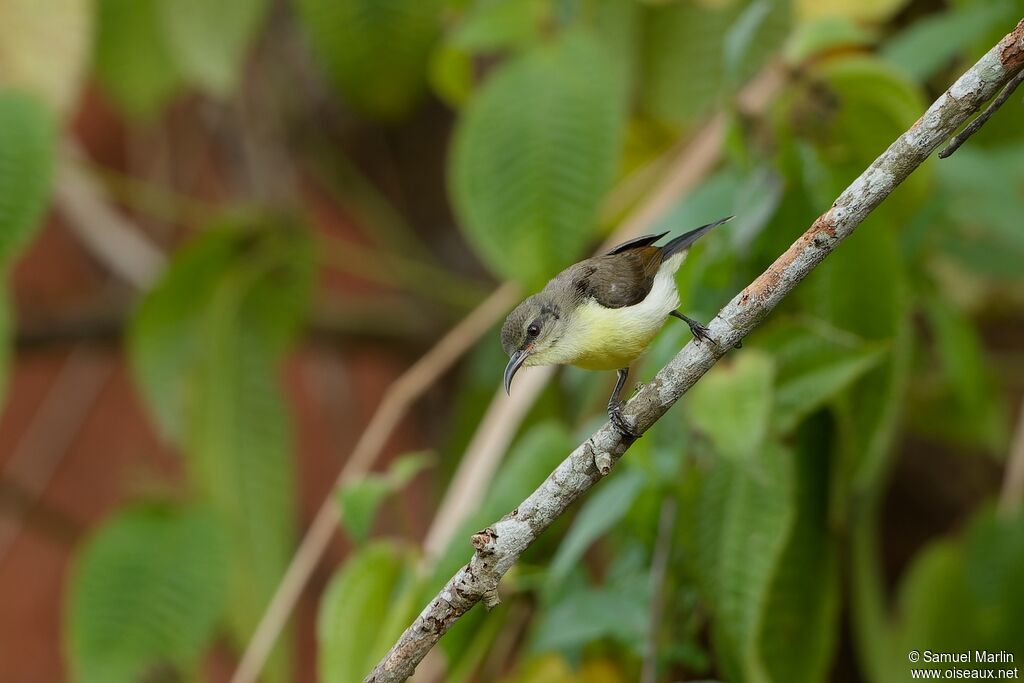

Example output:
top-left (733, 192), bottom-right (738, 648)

top-left (502, 216), bottom-right (733, 438)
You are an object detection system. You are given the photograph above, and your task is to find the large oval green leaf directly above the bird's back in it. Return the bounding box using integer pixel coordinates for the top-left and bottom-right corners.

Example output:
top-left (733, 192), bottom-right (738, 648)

top-left (450, 32), bottom-right (624, 286)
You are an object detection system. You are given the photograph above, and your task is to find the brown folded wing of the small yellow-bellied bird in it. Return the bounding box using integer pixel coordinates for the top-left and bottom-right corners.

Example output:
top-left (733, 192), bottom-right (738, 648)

top-left (572, 246), bottom-right (662, 308)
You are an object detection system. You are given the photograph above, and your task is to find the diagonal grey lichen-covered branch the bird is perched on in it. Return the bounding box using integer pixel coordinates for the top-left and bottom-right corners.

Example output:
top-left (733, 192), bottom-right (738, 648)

top-left (365, 19), bottom-right (1024, 683)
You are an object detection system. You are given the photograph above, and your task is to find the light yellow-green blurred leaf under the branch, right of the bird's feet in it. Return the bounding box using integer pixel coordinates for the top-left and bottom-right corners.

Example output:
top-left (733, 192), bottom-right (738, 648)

top-left (686, 350), bottom-right (775, 463)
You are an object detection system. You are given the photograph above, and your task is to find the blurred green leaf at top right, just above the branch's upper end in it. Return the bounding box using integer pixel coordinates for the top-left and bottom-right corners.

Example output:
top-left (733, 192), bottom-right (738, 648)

top-left (882, 0), bottom-right (1016, 81)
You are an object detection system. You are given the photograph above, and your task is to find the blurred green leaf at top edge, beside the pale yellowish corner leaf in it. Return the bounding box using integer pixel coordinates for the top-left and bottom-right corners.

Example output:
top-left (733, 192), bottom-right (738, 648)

top-left (94, 0), bottom-right (181, 118)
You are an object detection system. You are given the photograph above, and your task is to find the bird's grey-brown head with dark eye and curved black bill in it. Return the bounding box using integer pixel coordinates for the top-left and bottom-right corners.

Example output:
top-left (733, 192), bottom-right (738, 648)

top-left (502, 292), bottom-right (567, 392)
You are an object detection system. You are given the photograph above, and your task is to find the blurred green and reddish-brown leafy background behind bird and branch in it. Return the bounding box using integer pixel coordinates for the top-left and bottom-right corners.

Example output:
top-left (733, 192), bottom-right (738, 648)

top-left (0, 0), bottom-right (1024, 683)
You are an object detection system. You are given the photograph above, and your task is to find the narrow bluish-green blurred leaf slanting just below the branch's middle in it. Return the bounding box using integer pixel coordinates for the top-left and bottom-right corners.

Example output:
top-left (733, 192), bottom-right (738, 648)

top-left (548, 469), bottom-right (644, 587)
